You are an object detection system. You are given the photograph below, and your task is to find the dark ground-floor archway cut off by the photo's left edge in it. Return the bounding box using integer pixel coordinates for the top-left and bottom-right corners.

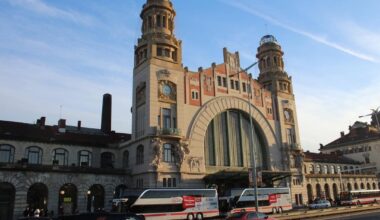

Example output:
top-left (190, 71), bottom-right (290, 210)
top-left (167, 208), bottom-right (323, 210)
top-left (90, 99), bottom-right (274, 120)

top-left (0, 182), bottom-right (16, 220)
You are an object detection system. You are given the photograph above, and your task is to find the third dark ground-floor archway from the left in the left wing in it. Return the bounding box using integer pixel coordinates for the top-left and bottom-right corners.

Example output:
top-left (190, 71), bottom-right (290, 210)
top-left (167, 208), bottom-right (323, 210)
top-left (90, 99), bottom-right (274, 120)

top-left (58, 183), bottom-right (78, 215)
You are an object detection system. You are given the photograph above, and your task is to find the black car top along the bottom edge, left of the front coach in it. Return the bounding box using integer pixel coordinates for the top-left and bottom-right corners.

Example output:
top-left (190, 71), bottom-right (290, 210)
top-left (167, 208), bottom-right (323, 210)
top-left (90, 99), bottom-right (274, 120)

top-left (58, 212), bottom-right (145, 220)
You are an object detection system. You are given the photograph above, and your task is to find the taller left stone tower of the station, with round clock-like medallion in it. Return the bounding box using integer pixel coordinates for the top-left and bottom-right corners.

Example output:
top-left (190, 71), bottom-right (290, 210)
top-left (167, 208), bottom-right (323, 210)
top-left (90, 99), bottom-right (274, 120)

top-left (129, 0), bottom-right (184, 187)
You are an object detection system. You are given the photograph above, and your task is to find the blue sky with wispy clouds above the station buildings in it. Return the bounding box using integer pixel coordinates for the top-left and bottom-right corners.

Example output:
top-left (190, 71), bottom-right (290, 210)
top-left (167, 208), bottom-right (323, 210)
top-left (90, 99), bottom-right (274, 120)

top-left (0, 0), bottom-right (380, 151)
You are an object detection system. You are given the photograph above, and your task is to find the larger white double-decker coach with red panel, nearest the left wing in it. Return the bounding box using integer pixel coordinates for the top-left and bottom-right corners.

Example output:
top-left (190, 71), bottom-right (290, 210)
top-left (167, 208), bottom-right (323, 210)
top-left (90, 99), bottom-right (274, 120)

top-left (113, 189), bottom-right (219, 220)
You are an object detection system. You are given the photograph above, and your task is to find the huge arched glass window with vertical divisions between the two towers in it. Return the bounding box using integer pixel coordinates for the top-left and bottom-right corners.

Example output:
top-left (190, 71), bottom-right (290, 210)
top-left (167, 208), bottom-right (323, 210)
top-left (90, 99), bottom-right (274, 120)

top-left (204, 109), bottom-right (266, 168)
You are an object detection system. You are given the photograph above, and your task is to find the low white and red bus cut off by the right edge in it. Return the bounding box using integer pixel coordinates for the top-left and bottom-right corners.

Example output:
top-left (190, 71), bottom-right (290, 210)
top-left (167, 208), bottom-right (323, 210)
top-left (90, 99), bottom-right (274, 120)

top-left (340, 189), bottom-right (380, 205)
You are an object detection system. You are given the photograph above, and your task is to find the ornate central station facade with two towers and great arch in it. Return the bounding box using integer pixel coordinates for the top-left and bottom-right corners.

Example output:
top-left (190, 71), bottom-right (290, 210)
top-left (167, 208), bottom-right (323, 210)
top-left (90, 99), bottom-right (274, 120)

top-left (121, 0), bottom-right (302, 199)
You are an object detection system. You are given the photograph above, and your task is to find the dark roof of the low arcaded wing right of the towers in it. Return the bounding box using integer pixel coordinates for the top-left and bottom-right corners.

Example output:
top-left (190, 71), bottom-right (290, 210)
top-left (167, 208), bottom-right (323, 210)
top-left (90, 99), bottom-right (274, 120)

top-left (304, 151), bottom-right (360, 164)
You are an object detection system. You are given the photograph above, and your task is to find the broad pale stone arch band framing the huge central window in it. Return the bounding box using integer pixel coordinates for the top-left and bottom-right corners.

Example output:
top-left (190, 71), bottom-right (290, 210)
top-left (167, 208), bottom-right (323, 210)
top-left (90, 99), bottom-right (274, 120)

top-left (187, 96), bottom-right (281, 170)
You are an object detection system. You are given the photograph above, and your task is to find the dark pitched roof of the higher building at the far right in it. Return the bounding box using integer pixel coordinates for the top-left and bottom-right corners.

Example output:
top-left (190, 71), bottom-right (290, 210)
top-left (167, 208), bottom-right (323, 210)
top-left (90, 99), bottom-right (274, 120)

top-left (322, 122), bottom-right (380, 149)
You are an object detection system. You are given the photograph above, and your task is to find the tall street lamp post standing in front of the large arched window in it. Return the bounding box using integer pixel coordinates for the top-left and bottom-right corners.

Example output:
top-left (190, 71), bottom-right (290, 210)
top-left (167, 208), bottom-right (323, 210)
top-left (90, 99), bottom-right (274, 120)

top-left (230, 61), bottom-right (259, 212)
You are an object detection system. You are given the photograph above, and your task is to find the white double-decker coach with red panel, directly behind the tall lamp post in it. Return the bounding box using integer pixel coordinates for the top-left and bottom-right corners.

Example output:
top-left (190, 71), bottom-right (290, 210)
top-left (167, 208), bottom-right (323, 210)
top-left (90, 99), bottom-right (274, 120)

top-left (229, 188), bottom-right (292, 213)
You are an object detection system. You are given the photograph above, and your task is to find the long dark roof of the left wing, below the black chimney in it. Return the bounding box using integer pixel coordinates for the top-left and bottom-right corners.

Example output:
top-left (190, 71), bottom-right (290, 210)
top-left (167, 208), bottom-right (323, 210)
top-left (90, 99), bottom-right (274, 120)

top-left (0, 120), bottom-right (131, 147)
